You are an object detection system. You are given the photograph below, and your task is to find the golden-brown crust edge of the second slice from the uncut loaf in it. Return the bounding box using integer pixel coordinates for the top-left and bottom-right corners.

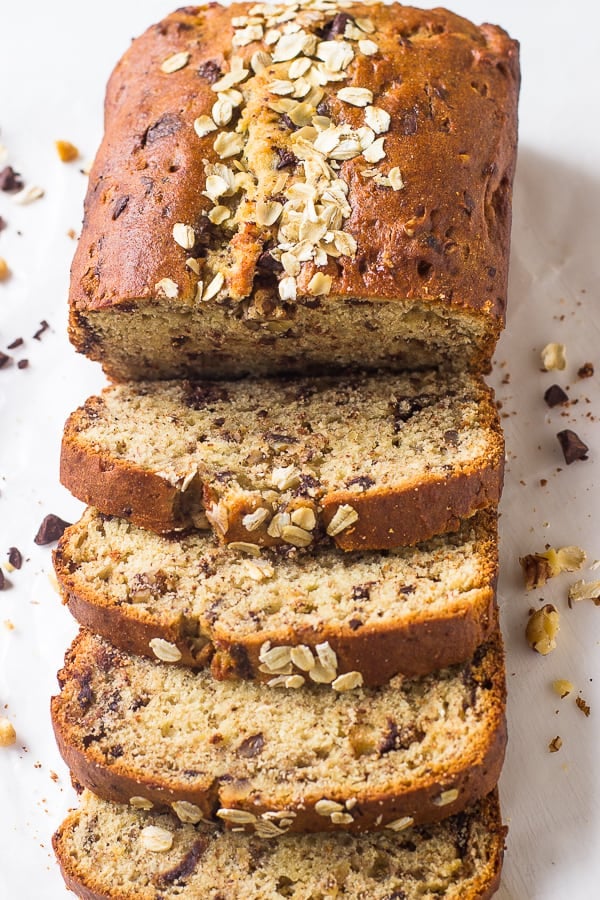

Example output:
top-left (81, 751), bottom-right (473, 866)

top-left (54, 534), bottom-right (498, 686)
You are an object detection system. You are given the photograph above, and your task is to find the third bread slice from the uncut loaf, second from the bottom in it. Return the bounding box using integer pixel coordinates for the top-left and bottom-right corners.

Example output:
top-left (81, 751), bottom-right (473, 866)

top-left (52, 632), bottom-right (506, 832)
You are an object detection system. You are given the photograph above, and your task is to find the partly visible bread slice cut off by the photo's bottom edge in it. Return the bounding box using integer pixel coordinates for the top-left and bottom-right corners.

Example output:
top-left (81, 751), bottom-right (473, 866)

top-left (53, 792), bottom-right (506, 900)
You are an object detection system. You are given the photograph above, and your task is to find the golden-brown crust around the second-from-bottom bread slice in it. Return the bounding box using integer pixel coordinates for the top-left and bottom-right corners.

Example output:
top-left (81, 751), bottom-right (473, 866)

top-left (51, 632), bottom-right (506, 833)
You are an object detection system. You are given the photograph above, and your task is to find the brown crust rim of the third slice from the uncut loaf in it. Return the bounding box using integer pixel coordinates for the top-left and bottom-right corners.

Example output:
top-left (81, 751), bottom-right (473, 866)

top-left (51, 632), bottom-right (506, 833)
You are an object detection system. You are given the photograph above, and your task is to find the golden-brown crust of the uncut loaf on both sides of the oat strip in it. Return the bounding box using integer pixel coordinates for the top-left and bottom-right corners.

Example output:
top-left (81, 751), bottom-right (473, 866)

top-left (70, 4), bottom-right (519, 378)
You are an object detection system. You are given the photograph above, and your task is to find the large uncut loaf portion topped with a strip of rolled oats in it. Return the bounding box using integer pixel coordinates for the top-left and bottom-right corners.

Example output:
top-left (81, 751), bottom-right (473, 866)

top-left (70, 0), bottom-right (519, 380)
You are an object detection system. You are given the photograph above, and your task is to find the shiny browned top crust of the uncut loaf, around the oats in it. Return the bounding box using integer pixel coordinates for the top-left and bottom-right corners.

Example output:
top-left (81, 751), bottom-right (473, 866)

top-left (70, 3), bottom-right (519, 328)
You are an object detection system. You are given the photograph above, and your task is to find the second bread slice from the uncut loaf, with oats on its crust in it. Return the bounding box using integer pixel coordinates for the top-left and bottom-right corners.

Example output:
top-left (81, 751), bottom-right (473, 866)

top-left (54, 509), bottom-right (498, 685)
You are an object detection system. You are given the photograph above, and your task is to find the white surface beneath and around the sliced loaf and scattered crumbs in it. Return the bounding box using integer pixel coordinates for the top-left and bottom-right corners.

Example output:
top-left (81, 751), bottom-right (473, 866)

top-left (0, 0), bottom-right (600, 900)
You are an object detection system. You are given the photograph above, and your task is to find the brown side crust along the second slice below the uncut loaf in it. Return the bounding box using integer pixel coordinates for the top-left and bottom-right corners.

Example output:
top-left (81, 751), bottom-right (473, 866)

top-left (54, 513), bottom-right (498, 686)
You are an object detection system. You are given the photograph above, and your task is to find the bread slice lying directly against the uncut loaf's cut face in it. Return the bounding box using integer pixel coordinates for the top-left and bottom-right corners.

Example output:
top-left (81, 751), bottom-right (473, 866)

top-left (61, 371), bottom-right (504, 552)
